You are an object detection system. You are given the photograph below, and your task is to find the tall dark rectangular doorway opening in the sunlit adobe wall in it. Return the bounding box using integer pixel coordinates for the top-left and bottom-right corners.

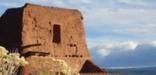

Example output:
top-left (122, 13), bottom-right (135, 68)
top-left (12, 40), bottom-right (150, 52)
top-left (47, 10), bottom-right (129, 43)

top-left (53, 24), bottom-right (61, 43)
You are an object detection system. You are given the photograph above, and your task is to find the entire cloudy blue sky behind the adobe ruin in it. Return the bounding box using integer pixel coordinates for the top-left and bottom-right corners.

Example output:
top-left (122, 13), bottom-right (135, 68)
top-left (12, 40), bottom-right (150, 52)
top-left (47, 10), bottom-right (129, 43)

top-left (0, 0), bottom-right (156, 67)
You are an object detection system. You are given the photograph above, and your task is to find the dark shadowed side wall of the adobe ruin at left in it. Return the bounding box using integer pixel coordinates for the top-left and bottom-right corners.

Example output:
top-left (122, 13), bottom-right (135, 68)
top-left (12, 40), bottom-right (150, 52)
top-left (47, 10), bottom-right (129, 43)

top-left (0, 8), bottom-right (23, 51)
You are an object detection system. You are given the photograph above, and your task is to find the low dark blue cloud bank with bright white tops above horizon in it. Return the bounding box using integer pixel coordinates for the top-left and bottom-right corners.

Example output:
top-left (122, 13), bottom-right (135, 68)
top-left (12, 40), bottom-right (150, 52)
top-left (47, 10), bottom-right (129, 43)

top-left (90, 39), bottom-right (156, 67)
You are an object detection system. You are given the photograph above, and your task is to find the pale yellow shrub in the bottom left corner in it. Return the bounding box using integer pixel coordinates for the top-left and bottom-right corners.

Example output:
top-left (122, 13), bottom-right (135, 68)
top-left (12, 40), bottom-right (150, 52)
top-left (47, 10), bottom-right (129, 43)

top-left (0, 46), bottom-right (28, 75)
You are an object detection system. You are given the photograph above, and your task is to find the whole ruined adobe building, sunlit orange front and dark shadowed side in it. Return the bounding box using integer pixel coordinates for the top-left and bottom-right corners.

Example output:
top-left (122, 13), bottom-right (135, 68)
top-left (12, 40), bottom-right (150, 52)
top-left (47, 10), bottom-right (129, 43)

top-left (0, 4), bottom-right (108, 75)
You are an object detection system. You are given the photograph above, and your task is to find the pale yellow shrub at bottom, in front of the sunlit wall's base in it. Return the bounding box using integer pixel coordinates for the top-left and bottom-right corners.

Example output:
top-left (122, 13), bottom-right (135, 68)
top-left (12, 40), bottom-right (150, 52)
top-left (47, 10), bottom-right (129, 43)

top-left (35, 57), bottom-right (79, 75)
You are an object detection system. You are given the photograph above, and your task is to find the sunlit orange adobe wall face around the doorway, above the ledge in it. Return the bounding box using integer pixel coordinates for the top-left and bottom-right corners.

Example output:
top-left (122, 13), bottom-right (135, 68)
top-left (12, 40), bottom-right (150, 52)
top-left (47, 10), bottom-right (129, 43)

top-left (22, 5), bottom-right (89, 57)
